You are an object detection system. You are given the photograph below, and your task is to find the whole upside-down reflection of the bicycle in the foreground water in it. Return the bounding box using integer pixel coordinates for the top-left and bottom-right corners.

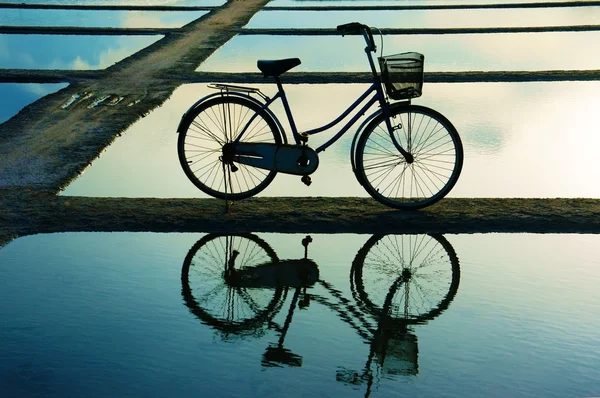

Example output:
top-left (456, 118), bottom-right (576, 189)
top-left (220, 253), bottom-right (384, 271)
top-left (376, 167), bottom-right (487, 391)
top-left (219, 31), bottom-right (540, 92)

top-left (181, 234), bottom-right (460, 396)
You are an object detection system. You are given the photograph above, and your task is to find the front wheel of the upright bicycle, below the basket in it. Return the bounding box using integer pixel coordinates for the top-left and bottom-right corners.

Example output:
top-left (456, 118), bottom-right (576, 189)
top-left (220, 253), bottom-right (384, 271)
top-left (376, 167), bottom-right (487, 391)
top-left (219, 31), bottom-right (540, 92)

top-left (356, 105), bottom-right (464, 209)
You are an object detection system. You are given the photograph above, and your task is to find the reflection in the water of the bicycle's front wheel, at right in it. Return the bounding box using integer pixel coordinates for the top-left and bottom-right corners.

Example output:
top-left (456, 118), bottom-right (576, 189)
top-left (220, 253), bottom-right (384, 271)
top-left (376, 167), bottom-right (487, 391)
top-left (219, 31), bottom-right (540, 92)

top-left (351, 235), bottom-right (460, 324)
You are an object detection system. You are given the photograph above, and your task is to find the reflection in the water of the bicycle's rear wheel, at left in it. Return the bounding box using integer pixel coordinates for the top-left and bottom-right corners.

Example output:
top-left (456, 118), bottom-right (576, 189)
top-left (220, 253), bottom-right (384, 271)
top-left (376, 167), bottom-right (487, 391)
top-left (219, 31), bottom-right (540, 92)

top-left (181, 234), bottom-right (282, 333)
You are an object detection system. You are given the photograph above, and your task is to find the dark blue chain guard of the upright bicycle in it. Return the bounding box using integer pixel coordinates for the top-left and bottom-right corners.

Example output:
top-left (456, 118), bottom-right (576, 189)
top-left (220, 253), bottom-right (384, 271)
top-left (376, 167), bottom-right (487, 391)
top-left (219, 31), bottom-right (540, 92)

top-left (229, 142), bottom-right (319, 176)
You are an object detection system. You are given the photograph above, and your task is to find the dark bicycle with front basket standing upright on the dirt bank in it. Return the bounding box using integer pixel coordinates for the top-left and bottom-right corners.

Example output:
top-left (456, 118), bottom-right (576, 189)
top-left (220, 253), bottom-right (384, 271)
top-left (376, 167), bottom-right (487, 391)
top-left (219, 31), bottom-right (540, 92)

top-left (177, 22), bottom-right (464, 209)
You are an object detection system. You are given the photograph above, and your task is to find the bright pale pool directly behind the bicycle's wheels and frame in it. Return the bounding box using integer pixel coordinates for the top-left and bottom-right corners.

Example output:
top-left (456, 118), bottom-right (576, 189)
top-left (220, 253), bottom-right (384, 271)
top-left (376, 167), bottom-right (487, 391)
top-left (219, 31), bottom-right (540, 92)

top-left (64, 82), bottom-right (600, 198)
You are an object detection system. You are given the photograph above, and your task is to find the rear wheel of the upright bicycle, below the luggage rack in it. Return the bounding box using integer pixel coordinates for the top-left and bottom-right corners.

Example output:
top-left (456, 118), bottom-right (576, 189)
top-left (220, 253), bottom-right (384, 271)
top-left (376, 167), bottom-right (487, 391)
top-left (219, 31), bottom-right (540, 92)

top-left (177, 96), bottom-right (281, 200)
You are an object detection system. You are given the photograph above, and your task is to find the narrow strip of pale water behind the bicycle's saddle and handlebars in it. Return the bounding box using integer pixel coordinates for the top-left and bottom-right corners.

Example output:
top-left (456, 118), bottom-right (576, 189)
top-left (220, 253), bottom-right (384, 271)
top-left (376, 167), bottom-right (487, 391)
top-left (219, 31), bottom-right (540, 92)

top-left (198, 31), bottom-right (600, 72)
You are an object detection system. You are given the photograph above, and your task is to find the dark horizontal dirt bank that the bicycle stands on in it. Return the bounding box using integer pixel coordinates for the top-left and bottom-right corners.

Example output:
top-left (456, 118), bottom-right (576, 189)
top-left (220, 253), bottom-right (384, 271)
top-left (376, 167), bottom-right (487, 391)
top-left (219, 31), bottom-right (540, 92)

top-left (0, 189), bottom-right (600, 247)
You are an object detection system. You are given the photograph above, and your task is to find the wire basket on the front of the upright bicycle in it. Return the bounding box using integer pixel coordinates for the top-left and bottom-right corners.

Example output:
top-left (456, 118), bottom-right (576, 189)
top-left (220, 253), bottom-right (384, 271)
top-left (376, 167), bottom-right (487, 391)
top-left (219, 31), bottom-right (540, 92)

top-left (379, 52), bottom-right (425, 100)
